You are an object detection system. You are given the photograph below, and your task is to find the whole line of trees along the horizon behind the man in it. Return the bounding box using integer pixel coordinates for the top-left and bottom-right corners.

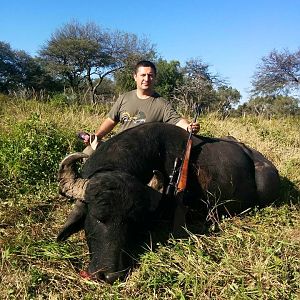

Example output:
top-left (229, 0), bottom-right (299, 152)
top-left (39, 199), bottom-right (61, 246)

top-left (0, 21), bottom-right (300, 116)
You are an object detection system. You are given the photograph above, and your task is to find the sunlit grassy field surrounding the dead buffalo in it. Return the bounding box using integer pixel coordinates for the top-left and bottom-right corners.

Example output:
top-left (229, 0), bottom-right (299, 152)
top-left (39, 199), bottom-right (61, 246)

top-left (0, 96), bottom-right (300, 299)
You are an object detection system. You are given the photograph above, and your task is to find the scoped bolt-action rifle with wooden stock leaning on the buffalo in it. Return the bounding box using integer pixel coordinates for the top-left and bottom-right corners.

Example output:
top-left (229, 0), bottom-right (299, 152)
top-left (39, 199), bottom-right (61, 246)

top-left (166, 104), bottom-right (200, 195)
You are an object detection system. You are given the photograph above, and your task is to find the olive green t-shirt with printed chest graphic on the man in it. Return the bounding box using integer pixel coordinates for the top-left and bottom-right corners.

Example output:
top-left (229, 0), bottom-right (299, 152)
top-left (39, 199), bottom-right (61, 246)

top-left (107, 90), bottom-right (181, 131)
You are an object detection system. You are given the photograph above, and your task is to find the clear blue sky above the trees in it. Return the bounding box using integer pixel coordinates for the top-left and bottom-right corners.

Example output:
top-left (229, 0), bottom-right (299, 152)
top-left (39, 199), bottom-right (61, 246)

top-left (0, 0), bottom-right (300, 102)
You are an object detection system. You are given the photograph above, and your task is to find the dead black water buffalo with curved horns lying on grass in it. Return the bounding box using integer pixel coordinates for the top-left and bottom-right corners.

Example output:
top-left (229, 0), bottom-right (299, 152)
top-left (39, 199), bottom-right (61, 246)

top-left (58, 123), bottom-right (279, 282)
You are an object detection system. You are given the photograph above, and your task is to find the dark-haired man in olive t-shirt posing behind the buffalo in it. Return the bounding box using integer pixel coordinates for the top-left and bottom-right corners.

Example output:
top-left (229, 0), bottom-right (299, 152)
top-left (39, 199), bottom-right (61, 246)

top-left (83, 60), bottom-right (200, 154)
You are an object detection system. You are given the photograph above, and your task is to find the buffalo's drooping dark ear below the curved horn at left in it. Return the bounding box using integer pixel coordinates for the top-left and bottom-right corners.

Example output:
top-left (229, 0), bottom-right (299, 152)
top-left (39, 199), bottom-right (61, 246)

top-left (57, 200), bottom-right (87, 242)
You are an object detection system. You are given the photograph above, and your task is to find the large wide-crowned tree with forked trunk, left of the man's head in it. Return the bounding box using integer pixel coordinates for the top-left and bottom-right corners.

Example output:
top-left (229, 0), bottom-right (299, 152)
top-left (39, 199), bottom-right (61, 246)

top-left (40, 21), bottom-right (154, 103)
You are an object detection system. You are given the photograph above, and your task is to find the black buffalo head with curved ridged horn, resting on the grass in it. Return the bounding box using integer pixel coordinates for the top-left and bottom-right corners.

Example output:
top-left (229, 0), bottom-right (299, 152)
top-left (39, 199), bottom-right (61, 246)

top-left (58, 153), bottom-right (161, 283)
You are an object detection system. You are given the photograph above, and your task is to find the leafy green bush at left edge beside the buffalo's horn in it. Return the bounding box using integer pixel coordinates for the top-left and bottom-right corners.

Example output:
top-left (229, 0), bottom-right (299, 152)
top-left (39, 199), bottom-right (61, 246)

top-left (0, 113), bottom-right (79, 198)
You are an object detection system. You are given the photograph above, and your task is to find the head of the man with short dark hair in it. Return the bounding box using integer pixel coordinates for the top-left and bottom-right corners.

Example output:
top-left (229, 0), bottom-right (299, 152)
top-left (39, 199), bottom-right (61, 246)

top-left (133, 60), bottom-right (156, 95)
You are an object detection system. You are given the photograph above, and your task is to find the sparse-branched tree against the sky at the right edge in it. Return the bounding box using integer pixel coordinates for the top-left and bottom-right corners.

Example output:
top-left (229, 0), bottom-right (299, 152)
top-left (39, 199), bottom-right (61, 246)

top-left (251, 50), bottom-right (300, 96)
